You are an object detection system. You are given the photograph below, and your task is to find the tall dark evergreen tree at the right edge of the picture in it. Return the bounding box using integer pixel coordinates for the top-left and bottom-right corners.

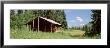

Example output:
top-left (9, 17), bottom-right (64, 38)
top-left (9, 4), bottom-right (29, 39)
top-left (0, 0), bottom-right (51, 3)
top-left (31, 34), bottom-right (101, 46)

top-left (87, 10), bottom-right (101, 36)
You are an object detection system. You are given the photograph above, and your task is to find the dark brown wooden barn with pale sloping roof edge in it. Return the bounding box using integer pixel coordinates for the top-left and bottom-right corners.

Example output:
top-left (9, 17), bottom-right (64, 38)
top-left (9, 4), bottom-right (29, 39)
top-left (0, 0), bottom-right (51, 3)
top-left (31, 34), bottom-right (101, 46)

top-left (26, 17), bottom-right (61, 32)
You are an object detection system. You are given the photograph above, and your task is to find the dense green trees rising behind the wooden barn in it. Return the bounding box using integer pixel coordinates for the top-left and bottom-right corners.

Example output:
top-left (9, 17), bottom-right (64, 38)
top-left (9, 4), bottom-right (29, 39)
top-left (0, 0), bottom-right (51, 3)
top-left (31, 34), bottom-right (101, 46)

top-left (10, 10), bottom-right (67, 29)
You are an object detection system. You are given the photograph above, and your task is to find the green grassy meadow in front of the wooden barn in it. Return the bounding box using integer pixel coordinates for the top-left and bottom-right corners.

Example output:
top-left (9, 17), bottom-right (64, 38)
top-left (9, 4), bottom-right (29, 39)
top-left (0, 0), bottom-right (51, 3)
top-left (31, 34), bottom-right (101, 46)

top-left (10, 29), bottom-right (100, 39)
